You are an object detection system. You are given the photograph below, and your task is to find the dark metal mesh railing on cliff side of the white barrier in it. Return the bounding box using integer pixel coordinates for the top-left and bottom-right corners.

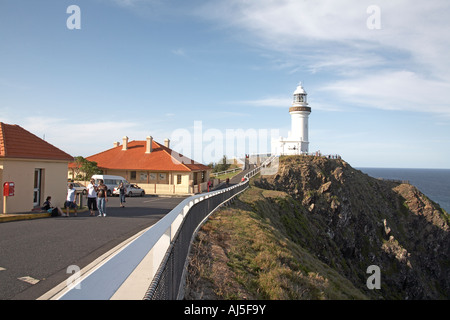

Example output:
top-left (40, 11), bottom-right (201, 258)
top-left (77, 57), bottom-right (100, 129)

top-left (144, 157), bottom-right (273, 300)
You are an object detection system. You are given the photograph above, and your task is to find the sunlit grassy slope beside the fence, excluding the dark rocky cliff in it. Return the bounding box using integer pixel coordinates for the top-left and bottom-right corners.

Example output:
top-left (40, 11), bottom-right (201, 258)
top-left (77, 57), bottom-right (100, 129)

top-left (185, 188), bottom-right (366, 300)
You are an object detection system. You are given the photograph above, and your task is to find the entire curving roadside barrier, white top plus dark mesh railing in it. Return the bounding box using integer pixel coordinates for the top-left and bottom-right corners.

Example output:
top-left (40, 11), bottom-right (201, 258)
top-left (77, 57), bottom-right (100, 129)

top-left (47, 158), bottom-right (273, 300)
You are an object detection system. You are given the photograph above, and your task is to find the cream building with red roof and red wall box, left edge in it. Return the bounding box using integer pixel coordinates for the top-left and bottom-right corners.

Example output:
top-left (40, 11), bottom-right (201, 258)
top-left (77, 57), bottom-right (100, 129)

top-left (0, 122), bottom-right (73, 213)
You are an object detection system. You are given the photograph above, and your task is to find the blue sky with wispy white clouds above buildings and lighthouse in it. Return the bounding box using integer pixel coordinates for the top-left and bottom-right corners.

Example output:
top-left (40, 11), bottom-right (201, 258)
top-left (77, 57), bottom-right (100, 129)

top-left (0, 0), bottom-right (450, 168)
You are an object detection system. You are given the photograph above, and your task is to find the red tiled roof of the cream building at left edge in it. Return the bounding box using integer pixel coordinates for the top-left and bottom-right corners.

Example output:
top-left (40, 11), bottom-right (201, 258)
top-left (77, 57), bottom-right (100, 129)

top-left (0, 122), bottom-right (73, 161)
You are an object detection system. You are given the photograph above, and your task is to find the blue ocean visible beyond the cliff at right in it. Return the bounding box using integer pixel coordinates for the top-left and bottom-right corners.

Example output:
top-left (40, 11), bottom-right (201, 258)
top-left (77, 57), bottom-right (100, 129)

top-left (356, 168), bottom-right (450, 213)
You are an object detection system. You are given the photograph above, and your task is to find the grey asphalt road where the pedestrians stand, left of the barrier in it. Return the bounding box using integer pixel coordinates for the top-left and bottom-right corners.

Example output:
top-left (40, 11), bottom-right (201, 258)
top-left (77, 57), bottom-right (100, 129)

top-left (0, 196), bottom-right (184, 300)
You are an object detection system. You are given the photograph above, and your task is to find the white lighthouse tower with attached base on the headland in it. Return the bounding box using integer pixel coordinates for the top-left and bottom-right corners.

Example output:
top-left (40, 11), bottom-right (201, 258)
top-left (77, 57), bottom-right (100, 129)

top-left (272, 83), bottom-right (311, 155)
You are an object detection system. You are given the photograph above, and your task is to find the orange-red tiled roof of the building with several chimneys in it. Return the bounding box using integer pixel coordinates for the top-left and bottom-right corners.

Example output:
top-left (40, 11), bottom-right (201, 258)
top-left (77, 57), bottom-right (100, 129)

top-left (86, 141), bottom-right (211, 172)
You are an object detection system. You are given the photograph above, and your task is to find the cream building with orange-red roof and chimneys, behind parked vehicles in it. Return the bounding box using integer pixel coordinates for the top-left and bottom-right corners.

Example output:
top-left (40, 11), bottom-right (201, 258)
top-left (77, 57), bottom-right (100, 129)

top-left (73, 136), bottom-right (211, 194)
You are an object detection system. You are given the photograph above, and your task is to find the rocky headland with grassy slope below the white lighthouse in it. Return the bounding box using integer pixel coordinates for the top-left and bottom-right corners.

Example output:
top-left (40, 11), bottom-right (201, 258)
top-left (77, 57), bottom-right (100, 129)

top-left (187, 156), bottom-right (450, 299)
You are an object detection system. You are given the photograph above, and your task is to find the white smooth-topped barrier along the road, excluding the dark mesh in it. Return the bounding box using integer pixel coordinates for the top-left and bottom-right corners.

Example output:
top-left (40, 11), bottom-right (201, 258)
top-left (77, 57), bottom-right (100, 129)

top-left (39, 157), bottom-right (273, 300)
